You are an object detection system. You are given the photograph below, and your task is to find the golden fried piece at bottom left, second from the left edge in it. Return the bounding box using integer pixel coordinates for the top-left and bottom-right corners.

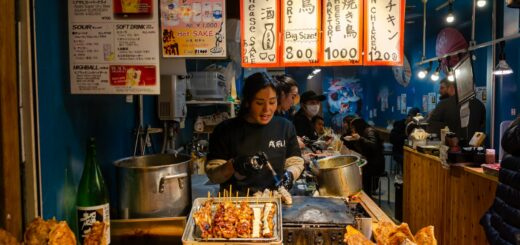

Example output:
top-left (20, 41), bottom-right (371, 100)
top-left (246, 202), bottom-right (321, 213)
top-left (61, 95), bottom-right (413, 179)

top-left (24, 217), bottom-right (58, 245)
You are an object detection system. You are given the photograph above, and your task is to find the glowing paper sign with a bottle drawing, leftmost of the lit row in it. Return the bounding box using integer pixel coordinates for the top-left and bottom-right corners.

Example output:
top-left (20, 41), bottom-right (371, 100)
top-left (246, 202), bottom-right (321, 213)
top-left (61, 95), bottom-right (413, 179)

top-left (240, 0), bottom-right (280, 67)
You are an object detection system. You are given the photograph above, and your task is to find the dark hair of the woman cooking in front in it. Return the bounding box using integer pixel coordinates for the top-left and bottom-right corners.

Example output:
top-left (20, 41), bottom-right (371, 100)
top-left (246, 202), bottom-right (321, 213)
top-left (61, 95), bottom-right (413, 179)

top-left (238, 72), bottom-right (277, 117)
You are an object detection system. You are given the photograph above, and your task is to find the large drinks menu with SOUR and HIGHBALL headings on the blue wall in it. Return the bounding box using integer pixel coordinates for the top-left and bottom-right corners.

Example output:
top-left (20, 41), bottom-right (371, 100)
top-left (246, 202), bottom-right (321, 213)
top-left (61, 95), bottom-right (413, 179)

top-left (68, 0), bottom-right (160, 94)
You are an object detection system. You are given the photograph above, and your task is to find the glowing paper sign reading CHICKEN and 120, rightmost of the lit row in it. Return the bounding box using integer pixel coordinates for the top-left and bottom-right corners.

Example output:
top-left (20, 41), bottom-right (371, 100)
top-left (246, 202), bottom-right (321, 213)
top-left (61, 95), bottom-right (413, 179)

top-left (363, 0), bottom-right (405, 66)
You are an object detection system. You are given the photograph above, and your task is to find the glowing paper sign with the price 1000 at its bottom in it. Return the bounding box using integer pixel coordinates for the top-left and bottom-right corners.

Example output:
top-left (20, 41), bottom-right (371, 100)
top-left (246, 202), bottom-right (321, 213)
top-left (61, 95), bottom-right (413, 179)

top-left (320, 0), bottom-right (363, 66)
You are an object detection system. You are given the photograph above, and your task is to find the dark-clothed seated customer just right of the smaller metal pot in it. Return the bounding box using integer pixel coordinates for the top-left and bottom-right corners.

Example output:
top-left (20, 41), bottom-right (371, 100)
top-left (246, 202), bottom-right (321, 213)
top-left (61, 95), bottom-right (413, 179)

top-left (345, 117), bottom-right (385, 194)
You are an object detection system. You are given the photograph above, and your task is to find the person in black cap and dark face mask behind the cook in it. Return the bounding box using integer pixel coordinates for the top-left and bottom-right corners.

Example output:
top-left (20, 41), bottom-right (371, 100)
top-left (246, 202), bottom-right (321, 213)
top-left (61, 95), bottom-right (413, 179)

top-left (293, 90), bottom-right (326, 140)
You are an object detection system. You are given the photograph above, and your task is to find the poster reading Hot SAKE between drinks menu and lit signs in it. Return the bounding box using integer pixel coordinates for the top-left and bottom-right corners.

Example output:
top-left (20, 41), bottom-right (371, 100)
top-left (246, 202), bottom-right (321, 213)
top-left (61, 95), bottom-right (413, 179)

top-left (160, 0), bottom-right (226, 58)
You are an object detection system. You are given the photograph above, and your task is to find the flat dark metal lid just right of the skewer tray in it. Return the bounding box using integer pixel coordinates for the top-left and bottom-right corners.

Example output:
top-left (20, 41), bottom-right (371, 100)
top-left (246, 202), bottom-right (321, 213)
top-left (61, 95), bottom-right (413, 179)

top-left (282, 196), bottom-right (355, 225)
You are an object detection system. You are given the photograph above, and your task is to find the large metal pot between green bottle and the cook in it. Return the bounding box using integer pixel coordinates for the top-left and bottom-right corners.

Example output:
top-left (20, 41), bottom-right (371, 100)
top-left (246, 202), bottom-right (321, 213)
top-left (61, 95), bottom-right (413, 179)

top-left (114, 154), bottom-right (191, 219)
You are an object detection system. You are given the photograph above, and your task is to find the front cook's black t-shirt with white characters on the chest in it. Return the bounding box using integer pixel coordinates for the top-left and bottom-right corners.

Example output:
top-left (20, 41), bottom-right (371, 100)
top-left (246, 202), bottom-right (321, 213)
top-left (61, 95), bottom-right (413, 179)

top-left (208, 117), bottom-right (301, 193)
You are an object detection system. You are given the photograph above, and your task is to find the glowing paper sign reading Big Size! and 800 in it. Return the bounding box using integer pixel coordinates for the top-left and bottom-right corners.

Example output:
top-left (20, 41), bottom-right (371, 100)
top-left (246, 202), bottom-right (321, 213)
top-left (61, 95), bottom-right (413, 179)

top-left (281, 0), bottom-right (321, 66)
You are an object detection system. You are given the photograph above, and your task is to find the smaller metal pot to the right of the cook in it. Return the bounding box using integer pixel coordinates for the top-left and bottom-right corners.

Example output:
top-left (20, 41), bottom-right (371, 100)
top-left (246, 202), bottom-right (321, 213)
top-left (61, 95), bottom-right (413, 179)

top-left (314, 155), bottom-right (366, 197)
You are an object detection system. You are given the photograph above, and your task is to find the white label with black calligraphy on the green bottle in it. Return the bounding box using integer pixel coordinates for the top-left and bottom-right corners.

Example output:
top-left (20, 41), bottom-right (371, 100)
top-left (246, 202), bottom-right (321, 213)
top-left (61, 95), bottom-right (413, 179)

top-left (77, 203), bottom-right (110, 244)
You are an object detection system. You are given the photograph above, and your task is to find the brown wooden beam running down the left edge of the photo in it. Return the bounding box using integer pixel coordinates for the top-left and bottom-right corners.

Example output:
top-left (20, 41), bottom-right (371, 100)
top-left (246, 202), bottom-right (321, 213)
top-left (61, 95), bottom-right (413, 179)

top-left (0, 0), bottom-right (22, 240)
